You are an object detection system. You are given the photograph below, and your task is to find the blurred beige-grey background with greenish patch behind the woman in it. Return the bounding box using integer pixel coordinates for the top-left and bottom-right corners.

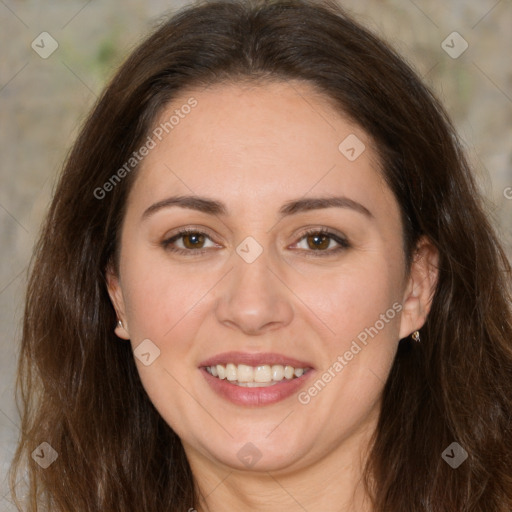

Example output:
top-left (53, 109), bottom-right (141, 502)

top-left (0, 0), bottom-right (512, 506)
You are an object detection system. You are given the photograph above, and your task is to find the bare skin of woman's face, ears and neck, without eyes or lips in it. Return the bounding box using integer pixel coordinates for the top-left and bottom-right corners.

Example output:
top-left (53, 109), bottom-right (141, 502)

top-left (108, 82), bottom-right (437, 512)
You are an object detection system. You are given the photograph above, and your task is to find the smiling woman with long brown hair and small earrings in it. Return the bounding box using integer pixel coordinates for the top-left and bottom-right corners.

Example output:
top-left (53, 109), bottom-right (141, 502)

top-left (9, 0), bottom-right (512, 512)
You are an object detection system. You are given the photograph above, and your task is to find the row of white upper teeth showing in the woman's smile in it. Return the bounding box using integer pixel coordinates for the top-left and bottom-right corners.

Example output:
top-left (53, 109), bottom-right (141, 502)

top-left (206, 363), bottom-right (307, 388)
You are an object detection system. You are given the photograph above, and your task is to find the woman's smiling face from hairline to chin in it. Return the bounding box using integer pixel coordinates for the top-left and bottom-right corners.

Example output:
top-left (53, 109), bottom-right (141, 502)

top-left (109, 82), bottom-right (434, 471)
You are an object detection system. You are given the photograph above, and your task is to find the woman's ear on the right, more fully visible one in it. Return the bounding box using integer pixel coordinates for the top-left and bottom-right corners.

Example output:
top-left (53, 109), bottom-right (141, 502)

top-left (400, 236), bottom-right (439, 339)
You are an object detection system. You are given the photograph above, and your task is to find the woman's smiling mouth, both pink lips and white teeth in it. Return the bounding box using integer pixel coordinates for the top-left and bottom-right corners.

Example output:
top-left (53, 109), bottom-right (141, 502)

top-left (199, 352), bottom-right (314, 405)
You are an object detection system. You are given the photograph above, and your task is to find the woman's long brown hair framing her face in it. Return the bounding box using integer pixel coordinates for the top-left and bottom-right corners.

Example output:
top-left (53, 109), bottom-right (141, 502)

top-left (11, 0), bottom-right (512, 512)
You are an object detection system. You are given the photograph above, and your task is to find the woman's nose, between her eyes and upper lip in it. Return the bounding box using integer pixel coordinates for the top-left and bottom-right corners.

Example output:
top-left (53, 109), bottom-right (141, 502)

top-left (216, 251), bottom-right (294, 336)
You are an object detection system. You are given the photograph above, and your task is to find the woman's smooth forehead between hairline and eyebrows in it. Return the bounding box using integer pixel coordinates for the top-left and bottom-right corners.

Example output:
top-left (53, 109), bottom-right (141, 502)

top-left (128, 82), bottom-right (393, 219)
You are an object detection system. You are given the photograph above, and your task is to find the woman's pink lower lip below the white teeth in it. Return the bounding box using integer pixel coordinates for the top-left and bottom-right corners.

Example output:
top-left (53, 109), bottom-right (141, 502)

top-left (201, 368), bottom-right (314, 406)
